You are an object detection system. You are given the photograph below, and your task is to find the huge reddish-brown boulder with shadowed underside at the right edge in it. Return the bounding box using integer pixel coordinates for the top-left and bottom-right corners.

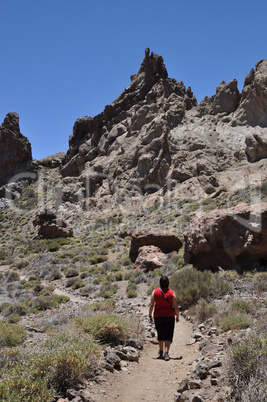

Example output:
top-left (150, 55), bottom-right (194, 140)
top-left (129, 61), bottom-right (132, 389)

top-left (184, 203), bottom-right (267, 271)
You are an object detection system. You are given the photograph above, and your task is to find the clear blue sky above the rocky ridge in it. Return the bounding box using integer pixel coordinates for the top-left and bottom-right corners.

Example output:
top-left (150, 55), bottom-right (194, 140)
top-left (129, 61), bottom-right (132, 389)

top-left (0, 0), bottom-right (267, 159)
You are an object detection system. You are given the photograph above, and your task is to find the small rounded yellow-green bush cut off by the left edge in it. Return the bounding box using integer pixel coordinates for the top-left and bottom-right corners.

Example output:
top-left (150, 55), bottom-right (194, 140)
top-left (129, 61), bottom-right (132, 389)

top-left (0, 320), bottom-right (27, 347)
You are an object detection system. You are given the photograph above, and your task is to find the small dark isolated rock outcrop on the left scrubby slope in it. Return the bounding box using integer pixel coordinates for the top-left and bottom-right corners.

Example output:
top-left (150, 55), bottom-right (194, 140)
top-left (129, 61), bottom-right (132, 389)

top-left (33, 211), bottom-right (73, 239)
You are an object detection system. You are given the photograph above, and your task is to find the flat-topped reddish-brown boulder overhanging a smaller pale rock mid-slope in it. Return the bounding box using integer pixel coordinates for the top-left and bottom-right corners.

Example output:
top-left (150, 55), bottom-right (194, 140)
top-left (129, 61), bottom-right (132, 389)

top-left (130, 227), bottom-right (183, 261)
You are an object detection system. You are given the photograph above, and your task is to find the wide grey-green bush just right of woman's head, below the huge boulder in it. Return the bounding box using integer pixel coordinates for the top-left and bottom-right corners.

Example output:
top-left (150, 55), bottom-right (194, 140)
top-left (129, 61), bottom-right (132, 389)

top-left (170, 267), bottom-right (232, 308)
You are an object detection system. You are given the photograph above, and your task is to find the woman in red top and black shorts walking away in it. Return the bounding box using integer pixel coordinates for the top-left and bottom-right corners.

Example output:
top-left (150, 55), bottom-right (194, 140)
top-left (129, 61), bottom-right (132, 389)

top-left (148, 275), bottom-right (179, 360)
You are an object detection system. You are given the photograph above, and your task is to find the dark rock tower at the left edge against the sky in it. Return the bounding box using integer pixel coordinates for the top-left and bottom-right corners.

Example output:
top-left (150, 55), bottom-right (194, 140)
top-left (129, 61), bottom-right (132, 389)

top-left (0, 113), bottom-right (32, 186)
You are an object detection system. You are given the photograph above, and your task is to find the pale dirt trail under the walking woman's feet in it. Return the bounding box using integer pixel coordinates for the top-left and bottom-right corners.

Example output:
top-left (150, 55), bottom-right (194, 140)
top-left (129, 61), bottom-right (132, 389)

top-left (106, 318), bottom-right (198, 402)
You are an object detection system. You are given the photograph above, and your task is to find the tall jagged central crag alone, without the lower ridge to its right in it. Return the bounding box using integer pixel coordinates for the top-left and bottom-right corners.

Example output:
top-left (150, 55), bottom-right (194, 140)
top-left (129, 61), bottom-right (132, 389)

top-left (61, 49), bottom-right (196, 206)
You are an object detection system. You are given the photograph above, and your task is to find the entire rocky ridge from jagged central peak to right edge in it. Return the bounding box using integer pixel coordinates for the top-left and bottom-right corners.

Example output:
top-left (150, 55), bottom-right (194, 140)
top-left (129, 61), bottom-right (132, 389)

top-left (61, 49), bottom-right (267, 212)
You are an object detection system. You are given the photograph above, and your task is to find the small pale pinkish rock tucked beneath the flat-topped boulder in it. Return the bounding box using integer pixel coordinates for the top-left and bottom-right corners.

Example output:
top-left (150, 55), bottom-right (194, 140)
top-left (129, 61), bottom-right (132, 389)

top-left (133, 246), bottom-right (166, 272)
